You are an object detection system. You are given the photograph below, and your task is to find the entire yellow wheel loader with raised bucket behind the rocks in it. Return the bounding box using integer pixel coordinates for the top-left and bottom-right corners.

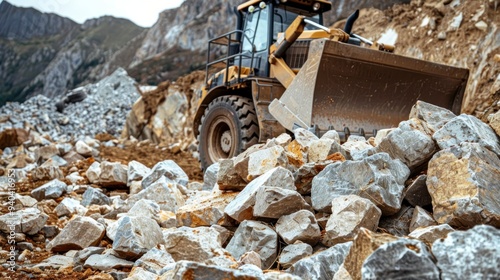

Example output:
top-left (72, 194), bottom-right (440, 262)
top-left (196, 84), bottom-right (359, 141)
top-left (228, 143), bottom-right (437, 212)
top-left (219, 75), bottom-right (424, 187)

top-left (193, 0), bottom-right (469, 170)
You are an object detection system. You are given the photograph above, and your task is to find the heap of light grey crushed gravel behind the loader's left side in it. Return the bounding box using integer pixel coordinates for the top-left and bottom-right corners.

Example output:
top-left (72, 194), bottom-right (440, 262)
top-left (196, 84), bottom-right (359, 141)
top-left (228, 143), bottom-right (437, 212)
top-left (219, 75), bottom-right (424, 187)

top-left (0, 68), bottom-right (140, 140)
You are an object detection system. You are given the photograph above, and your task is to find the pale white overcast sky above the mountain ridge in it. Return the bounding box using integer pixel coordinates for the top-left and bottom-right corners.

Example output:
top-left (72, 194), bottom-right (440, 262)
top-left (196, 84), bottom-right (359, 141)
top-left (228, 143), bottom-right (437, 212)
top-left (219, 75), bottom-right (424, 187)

top-left (0, 0), bottom-right (184, 27)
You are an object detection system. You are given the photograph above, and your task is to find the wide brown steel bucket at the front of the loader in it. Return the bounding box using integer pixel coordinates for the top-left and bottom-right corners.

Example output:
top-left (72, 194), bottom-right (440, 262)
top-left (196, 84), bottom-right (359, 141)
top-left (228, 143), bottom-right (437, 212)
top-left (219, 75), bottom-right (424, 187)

top-left (269, 39), bottom-right (469, 136)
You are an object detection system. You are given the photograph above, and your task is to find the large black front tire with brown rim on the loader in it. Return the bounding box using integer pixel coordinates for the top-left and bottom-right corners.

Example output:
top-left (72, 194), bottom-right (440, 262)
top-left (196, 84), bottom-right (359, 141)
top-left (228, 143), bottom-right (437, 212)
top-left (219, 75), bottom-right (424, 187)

top-left (198, 95), bottom-right (259, 170)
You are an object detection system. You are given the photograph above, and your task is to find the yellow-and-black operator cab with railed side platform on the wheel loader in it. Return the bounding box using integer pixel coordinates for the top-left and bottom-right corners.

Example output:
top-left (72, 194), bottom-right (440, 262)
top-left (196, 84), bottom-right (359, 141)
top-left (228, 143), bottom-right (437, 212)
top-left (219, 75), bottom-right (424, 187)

top-left (206, 0), bottom-right (331, 89)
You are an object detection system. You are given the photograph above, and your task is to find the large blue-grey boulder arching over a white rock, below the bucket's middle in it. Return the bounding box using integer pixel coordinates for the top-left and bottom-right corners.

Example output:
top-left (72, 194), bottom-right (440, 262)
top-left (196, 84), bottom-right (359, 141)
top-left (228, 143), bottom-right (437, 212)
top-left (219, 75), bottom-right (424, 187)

top-left (311, 153), bottom-right (410, 215)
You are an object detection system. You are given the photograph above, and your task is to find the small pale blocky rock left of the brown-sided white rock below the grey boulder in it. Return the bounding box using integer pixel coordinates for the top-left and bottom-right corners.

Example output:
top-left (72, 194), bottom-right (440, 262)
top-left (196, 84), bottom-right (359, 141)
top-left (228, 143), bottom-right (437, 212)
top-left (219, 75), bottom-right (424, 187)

top-left (276, 210), bottom-right (321, 245)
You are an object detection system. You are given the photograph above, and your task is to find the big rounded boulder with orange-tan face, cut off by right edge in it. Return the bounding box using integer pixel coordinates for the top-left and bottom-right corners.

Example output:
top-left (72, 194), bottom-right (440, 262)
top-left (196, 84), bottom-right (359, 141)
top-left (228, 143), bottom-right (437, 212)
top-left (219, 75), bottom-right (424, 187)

top-left (427, 143), bottom-right (500, 228)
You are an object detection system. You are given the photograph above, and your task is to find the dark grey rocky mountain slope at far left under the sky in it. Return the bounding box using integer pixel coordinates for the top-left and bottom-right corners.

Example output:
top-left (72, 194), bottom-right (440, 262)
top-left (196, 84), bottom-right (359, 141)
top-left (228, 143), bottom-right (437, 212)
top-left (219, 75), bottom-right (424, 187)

top-left (0, 1), bottom-right (144, 105)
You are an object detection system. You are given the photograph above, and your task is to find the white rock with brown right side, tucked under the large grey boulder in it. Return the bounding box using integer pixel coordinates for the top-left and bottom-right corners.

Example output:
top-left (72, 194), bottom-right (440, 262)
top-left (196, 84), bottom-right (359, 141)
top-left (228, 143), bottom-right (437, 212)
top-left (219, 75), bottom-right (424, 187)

top-left (322, 195), bottom-right (382, 247)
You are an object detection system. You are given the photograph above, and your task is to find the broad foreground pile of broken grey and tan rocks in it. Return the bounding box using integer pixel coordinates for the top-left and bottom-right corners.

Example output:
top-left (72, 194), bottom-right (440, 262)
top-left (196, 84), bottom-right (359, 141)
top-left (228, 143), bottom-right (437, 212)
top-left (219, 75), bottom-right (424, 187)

top-left (0, 102), bottom-right (500, 279)
